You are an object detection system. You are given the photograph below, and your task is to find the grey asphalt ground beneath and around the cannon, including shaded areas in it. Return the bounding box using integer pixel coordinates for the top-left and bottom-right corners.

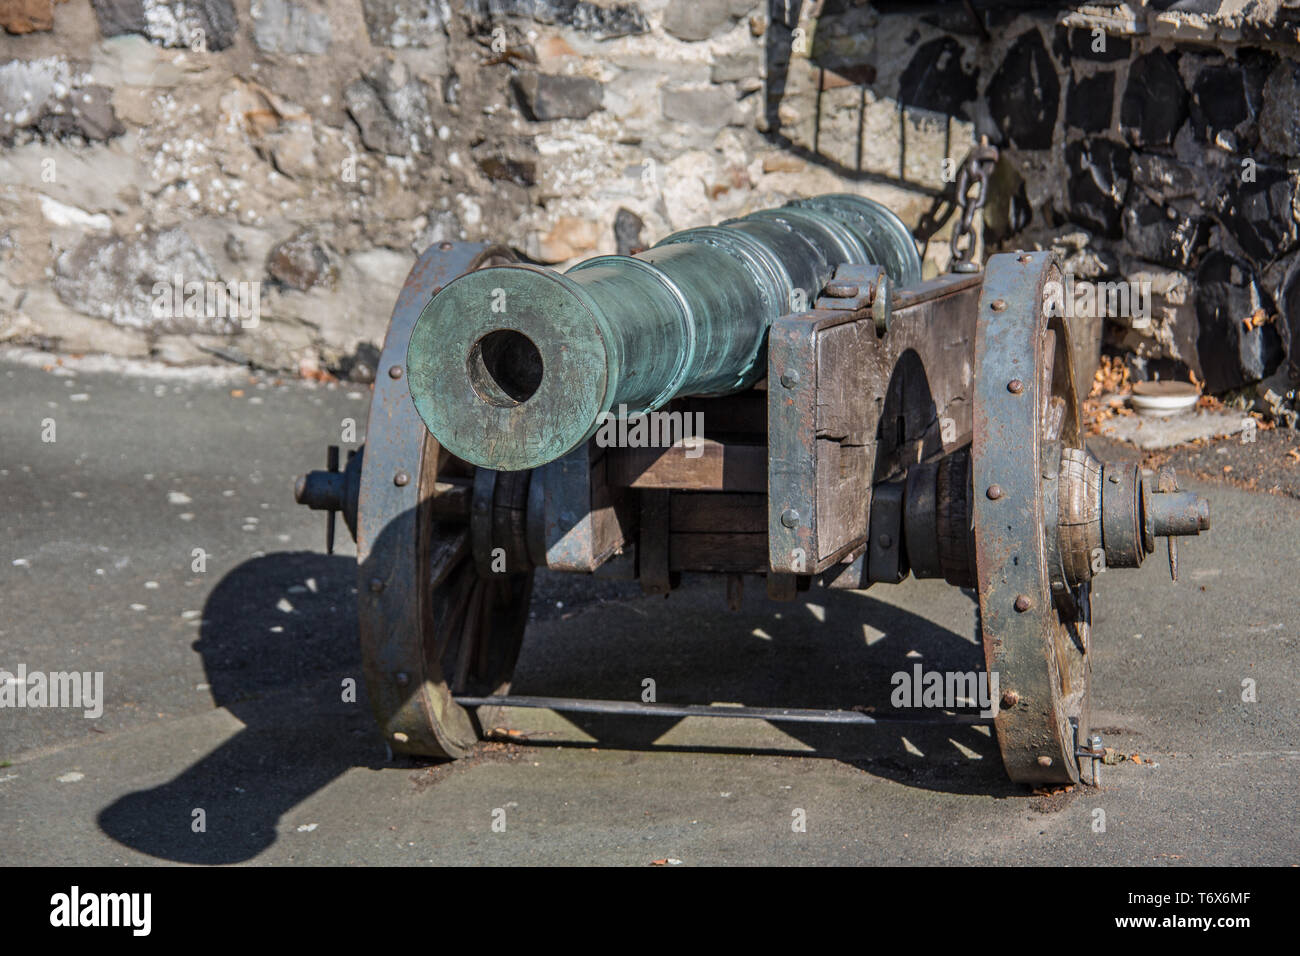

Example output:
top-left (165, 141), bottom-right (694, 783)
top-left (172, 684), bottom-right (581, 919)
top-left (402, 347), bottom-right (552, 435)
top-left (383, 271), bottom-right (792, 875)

top-left (0, 355), bottom-right (1300, 866)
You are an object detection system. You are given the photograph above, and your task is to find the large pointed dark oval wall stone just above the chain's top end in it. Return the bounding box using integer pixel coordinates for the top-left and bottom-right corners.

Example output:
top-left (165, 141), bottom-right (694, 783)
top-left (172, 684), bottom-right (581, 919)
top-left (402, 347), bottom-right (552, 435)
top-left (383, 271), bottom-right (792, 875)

top-left (987, 29), bottom-right (1061, 150)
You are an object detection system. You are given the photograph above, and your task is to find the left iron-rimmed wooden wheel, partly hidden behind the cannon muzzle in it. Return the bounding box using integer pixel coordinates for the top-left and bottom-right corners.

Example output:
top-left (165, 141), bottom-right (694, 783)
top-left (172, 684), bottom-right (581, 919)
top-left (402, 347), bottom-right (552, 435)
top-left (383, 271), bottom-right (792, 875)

top-left (356, 242), bottom-right (533, 757)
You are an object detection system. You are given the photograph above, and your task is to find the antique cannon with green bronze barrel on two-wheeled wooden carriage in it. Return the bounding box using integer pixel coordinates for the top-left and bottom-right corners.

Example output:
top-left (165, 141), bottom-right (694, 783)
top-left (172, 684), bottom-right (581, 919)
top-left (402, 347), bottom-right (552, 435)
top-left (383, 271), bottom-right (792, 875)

top-left (295, 195), bottom-right (1209, 784)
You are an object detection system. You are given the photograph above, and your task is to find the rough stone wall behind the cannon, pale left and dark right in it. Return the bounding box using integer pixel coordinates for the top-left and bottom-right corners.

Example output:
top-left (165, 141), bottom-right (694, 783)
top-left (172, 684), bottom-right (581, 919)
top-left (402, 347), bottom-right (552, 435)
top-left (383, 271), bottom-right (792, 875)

top-left (0, 0), bottom-right (1300, 413)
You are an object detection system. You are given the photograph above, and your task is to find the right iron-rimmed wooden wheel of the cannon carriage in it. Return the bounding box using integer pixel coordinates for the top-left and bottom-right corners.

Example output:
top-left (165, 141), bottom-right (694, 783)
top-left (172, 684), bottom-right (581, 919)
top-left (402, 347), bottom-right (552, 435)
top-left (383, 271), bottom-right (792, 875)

top-left (971, 252), bottom-right (1100, 784)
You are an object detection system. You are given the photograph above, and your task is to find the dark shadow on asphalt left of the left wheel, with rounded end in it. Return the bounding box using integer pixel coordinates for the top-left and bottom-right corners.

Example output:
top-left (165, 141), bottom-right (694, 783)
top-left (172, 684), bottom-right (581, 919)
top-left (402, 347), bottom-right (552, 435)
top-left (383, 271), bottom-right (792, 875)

top-left (99, 551), bottom-right (393, 864)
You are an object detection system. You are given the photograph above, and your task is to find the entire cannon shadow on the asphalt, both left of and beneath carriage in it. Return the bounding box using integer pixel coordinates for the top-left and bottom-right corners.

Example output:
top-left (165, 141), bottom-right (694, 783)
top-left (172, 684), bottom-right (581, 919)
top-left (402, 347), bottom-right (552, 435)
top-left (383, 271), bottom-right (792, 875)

top-left (98, 538), bottom-right (1024, 865)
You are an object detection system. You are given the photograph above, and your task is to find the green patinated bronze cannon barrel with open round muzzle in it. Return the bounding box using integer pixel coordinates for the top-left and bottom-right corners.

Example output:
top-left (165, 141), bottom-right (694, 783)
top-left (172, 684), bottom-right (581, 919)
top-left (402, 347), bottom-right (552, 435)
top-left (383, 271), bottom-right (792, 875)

top-left (407, 195), bottom-right (920, 471)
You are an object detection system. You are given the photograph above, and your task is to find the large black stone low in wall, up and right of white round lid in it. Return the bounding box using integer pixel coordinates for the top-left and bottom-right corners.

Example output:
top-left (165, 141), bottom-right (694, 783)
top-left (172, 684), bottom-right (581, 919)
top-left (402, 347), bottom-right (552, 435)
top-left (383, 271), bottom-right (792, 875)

top-left (1196, 250), bottom-right (1283, 393)
